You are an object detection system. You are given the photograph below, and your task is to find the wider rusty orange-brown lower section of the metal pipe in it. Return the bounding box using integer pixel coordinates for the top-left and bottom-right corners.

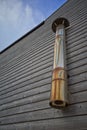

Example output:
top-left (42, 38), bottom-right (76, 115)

top-left (50, 67), bottom-right (68, 108)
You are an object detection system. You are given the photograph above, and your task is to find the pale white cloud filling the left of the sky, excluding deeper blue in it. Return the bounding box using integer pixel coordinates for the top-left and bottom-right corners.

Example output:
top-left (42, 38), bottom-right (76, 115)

top-left (0, 0), bottom-right (44, 50)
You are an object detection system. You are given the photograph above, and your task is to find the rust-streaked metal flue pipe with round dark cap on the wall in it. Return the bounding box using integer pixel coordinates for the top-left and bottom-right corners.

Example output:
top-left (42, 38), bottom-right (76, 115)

top-left (50, 18), bottom-right (69, 108)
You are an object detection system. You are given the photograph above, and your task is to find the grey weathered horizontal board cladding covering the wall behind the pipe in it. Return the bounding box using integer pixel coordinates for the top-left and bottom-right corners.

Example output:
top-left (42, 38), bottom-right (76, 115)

top-left (0, 0), bottom-right (87, 130)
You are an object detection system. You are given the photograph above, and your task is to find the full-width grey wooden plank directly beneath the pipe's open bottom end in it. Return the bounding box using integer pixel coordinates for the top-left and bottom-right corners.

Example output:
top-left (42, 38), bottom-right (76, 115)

top-left (0, 103), bottom-right (87, 125)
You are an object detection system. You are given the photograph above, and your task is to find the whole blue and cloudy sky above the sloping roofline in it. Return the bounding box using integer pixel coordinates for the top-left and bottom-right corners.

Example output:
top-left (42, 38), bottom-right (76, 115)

top-left (0, 0), bottom-right (67, 51)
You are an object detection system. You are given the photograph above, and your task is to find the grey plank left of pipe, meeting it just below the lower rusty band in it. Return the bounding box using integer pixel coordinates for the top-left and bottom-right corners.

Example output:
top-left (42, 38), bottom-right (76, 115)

top-left (0, 84), bottom-right (51, 104)
